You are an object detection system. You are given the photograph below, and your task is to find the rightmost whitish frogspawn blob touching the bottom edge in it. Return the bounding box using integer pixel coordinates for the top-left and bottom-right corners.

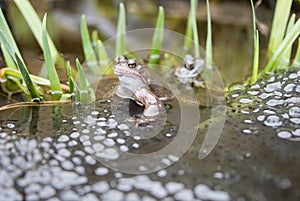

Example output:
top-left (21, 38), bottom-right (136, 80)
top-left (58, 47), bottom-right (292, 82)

top-left (194, 184), bottom-right (230, 201)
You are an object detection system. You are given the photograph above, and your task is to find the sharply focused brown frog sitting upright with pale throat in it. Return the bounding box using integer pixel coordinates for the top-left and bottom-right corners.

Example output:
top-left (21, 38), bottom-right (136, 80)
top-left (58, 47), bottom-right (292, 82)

top-left (114, 56), bottom-right (164, 124)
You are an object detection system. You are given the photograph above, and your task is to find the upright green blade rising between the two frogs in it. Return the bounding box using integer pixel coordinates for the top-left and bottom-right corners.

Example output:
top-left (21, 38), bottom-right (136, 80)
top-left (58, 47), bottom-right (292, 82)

top-left (149, 6), bottom-right (165, 65)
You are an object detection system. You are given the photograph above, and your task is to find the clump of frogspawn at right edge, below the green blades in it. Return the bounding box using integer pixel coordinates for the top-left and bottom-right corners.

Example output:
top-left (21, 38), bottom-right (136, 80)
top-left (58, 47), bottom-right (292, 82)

top-left (228, 70), bottom-right (300, 141)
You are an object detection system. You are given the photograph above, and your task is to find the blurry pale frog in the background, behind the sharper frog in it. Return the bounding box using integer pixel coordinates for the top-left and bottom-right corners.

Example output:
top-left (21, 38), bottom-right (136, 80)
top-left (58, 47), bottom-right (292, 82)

top-left (175, 54), bottom-right (204, 87)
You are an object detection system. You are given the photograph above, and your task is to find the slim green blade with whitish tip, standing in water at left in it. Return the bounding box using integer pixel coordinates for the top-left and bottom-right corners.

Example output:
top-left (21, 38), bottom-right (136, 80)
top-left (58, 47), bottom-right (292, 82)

top-left (42, 14), bottom-right (63, 100)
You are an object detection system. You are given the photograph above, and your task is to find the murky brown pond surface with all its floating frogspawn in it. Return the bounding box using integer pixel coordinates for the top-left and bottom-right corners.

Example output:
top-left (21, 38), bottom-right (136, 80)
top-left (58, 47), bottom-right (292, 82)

top-left (0, 71), bottom-right (300, 200)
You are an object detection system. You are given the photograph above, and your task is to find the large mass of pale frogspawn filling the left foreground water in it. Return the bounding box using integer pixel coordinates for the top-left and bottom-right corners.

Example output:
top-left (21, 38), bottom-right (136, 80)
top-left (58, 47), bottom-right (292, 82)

top-left (0, 100), bottom-right (230, 201)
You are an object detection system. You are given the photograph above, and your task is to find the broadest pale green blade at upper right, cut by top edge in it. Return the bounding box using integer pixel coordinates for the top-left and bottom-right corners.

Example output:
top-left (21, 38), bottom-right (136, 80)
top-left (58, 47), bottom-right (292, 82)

top-left (267, 0), bottom-right (293, 58)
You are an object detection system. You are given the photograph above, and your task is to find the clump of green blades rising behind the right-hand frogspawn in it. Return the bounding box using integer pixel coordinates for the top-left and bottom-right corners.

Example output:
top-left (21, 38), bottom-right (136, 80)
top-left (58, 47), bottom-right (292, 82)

top-left (246, 0), bottom-right (300, 84)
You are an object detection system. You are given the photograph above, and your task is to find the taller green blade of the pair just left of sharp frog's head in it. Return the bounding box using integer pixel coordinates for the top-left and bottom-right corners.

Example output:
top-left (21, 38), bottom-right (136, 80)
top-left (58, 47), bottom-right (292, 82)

top-left (80, 15), bottom-right (100, 74)
